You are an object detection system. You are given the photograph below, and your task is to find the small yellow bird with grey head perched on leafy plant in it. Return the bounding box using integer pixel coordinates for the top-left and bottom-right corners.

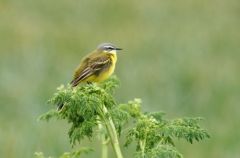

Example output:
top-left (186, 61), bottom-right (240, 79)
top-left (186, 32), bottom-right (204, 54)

top-left (58, 43), bottom-right (122, 110)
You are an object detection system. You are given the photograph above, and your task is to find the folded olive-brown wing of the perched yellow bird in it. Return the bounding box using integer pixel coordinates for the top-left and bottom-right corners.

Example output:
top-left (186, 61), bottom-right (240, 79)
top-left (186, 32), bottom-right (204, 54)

top-left (71, 54), bottom-right (111, 87)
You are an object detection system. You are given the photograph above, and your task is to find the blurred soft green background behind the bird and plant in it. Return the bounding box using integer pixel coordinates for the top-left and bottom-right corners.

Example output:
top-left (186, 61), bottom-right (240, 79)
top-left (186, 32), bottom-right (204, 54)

top-left (0, 0), bottom-right (240, 158)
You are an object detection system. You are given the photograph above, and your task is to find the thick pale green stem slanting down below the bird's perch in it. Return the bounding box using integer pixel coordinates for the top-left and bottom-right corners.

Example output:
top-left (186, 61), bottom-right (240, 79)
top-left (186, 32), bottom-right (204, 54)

top-left (103, 106), bottom-right (123, 158)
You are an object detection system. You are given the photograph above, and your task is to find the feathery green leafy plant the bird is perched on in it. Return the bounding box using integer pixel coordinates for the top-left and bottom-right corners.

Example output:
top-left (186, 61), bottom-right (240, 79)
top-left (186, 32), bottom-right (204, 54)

top-left (36, 77), bottom-right (209, 158)
